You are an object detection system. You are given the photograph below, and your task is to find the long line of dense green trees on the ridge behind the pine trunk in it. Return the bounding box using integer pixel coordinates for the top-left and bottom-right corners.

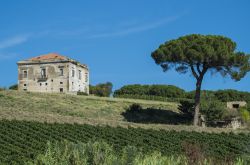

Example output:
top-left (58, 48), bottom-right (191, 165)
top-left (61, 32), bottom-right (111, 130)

top-left (113, 84), bottom-right (250, 103)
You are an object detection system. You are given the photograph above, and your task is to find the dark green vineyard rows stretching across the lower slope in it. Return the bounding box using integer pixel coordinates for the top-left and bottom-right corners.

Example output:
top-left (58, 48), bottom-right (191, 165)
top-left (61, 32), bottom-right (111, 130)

top-left (0, 120), bottom-right (250, 164)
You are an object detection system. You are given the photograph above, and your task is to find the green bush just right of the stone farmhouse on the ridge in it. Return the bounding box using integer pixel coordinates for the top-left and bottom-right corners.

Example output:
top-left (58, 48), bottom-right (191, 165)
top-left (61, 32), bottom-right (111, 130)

top-left (89, 82), bottom-right (113, 97)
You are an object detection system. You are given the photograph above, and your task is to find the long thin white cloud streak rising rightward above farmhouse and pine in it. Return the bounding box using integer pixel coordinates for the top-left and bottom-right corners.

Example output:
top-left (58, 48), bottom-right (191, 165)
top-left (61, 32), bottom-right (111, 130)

top-left (89, 16), bottom-right (181, 38)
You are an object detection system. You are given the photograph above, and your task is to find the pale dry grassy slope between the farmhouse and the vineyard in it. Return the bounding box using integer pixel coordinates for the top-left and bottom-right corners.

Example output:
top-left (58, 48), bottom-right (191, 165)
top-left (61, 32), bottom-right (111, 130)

top-left (0, 90), bottom-right (237, 132)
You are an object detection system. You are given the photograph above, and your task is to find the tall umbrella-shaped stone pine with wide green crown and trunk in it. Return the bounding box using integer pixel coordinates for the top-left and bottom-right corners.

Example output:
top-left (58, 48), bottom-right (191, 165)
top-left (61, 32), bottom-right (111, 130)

top-left (151, 34), bottom-right (250, 126)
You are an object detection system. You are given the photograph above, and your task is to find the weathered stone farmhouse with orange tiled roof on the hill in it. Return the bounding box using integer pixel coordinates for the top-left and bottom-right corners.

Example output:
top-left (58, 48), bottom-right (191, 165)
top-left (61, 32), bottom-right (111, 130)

top-left (17, 53), bottom-right (89, 94)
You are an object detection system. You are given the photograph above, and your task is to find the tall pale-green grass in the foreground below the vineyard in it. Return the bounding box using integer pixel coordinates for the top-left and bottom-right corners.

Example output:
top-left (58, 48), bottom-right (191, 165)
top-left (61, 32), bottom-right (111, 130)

top-left (26, 141), bottom-right (246, 165)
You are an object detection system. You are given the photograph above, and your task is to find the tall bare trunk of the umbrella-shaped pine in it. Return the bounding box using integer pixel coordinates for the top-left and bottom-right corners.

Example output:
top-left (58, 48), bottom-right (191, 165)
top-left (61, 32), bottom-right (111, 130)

top-left (194, 76), bottom-right (203, 126)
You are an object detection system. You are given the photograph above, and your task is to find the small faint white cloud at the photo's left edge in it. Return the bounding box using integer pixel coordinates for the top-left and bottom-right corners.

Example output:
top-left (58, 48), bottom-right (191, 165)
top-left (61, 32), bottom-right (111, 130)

top-left (0, 35), bottom-right (30, 49)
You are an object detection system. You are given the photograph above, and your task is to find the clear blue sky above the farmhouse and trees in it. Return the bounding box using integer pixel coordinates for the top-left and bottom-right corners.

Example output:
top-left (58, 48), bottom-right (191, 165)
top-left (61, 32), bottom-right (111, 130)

top-left (0, 0), bottom-right (250, 91)
